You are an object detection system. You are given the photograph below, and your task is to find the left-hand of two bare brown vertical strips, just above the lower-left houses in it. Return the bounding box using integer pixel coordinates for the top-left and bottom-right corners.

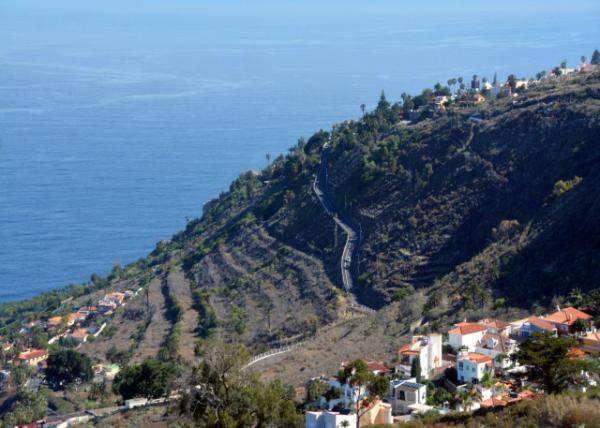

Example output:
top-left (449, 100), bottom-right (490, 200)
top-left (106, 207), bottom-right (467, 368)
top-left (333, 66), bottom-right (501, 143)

top-left (134, 278), bottom-right (171, 361)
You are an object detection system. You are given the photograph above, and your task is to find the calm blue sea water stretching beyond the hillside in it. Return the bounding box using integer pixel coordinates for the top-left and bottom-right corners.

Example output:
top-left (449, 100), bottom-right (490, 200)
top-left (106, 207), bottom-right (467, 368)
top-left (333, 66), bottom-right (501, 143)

top-left (0, 0), bottom-right (600, 301)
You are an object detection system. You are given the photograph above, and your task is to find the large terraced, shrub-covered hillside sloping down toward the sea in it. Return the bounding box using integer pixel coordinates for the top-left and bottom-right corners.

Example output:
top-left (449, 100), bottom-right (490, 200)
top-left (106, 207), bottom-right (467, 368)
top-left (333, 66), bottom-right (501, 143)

top-left (0, 73), bottom-right (600, 372)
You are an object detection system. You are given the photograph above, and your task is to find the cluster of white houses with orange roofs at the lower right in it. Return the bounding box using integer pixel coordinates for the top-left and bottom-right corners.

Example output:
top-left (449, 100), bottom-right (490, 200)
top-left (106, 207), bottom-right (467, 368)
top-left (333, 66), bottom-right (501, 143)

top-left (305, 307), bottom-right (600, 428)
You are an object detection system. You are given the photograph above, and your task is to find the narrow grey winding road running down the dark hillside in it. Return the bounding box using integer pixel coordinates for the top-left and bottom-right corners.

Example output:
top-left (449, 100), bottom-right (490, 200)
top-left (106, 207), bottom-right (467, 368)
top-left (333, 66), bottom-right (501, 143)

top-left (313, 142), bottom-right (374, 312)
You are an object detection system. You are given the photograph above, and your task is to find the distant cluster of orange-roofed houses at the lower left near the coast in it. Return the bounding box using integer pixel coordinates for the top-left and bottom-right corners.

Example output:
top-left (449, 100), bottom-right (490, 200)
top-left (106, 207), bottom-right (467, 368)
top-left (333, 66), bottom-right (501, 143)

top-left (0, 290), bottom-right (140, 383)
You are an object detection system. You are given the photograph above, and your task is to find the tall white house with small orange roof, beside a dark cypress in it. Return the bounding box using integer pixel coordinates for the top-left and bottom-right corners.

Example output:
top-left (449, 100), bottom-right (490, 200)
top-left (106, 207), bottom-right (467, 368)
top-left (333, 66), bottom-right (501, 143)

top-left (395, 334), bottom-right (442, 379)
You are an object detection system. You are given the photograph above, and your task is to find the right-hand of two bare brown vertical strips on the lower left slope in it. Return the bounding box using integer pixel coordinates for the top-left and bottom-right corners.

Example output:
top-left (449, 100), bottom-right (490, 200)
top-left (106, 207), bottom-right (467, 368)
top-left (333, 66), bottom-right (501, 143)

top-left (167, 269), bottom-right (198, 361)
